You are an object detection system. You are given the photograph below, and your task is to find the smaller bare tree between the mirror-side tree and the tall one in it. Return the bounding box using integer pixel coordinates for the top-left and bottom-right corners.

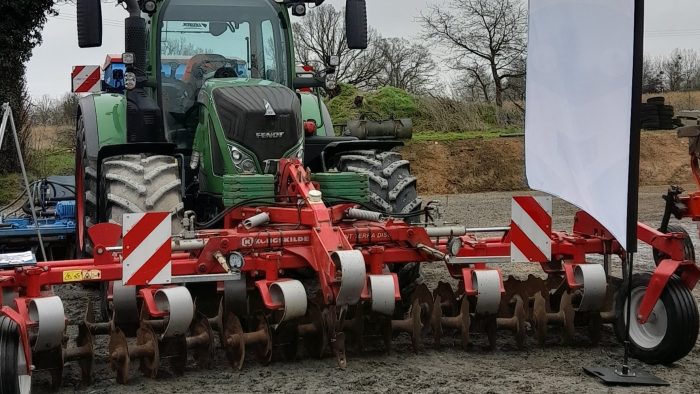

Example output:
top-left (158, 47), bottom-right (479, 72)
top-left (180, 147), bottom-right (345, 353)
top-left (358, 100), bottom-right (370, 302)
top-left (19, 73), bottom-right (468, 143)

top-left (376, 38), bottom-right (437, 93)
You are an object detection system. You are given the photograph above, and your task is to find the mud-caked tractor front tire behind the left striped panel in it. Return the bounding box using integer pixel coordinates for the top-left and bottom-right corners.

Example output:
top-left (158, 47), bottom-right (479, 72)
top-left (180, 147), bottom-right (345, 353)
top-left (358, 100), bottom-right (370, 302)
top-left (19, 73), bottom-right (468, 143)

top-left (99, 154), bottom-right (184, 320)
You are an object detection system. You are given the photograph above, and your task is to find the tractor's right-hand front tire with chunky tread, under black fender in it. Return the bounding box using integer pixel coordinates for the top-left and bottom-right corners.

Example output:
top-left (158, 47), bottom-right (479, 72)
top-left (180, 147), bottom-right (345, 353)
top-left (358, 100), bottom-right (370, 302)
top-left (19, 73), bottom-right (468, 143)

top-left (337, 150), bottom-right (423, 303)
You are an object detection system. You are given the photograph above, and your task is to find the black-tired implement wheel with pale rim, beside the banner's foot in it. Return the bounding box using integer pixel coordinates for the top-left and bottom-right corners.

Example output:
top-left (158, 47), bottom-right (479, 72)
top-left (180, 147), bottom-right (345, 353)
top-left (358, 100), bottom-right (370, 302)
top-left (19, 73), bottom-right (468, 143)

top-left (615, 273), bottom-right (699, 364)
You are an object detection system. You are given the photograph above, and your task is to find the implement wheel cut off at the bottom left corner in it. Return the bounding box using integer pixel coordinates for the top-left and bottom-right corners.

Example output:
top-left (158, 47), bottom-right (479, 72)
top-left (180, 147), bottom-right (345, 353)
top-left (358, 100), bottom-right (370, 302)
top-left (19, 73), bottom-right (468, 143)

top-left (0, 316), bottom-right (32, 394)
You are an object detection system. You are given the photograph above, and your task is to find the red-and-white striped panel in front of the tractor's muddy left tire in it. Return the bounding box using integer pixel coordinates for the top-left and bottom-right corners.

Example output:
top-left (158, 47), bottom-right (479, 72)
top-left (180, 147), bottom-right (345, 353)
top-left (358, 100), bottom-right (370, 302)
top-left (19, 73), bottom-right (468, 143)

top-left (122, 212), bottom-right (172, 286)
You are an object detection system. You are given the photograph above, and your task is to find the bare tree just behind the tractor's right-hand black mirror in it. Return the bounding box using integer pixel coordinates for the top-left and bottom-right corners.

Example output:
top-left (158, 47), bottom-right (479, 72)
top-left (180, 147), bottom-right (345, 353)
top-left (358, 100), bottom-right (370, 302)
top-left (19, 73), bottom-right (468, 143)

top-left (293, 5), bottom-right (382, 90)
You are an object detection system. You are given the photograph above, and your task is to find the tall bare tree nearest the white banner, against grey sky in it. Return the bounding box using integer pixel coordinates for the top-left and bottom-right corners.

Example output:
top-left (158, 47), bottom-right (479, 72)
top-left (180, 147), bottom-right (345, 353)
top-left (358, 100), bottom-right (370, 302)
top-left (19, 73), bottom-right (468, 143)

top-left (421, 0), bottom-right (527, 106)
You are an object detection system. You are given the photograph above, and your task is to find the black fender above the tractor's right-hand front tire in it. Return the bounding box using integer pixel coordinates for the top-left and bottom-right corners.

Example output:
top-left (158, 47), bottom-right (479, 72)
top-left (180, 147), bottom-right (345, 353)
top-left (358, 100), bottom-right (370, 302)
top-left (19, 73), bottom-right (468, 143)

top-left (304, 136), bottom-right (404, 172)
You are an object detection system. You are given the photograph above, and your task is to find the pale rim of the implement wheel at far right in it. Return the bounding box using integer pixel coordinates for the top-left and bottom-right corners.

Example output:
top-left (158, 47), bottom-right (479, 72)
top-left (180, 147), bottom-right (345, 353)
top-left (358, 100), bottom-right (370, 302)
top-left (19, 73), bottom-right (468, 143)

top-left (623, 287), bottom-right (668, 349)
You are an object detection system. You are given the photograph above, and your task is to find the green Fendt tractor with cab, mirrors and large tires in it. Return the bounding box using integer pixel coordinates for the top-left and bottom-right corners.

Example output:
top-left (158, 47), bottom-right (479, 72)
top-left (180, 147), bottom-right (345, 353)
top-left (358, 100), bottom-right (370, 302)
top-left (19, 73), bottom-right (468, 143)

top-left (76, 0), bottom-right (421, 290)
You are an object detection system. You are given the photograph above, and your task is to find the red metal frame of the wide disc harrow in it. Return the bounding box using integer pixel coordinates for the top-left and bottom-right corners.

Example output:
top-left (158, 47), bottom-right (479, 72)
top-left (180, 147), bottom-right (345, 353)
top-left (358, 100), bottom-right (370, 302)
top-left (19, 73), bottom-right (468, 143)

top-left (0, 160), bottom-right (700, 372)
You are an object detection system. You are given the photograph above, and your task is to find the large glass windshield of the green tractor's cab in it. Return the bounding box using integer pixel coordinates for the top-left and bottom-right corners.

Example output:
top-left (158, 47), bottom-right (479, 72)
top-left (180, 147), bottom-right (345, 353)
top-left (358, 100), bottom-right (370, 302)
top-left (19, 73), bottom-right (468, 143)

top-left (159, 0), bottom-right (289, 132)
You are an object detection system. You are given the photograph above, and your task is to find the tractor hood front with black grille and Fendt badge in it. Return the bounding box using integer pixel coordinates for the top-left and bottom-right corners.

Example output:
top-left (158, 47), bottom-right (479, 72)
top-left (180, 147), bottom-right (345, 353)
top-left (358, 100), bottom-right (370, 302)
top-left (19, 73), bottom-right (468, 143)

top-left (200, 78), bottom-right (303, 162)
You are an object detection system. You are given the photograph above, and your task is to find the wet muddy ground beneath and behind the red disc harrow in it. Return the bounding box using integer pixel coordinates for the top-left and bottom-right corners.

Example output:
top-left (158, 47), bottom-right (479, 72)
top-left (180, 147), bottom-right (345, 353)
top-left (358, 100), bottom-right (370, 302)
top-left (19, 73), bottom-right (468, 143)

top-left (41, 187), bottom-right (700, 393)
